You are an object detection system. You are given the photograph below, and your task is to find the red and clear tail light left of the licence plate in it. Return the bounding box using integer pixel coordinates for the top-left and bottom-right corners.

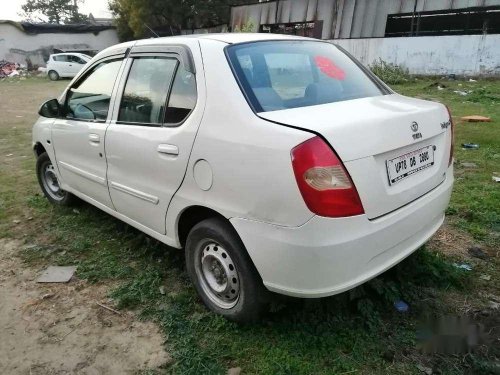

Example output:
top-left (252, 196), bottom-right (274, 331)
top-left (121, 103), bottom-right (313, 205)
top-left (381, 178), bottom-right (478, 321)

top-left (291, 137), bottom-right (364, 217)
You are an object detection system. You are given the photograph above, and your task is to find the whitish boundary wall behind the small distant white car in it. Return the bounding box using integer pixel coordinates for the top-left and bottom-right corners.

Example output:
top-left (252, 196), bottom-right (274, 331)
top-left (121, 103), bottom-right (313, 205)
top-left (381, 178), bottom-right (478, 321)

top-left (0, 24), bottom-right (119, 66)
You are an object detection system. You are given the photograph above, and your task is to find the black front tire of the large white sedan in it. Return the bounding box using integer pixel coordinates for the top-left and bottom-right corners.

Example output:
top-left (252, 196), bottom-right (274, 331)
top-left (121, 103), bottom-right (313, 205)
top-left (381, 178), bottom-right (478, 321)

top-left (36, 152), bottom-right (77, 206)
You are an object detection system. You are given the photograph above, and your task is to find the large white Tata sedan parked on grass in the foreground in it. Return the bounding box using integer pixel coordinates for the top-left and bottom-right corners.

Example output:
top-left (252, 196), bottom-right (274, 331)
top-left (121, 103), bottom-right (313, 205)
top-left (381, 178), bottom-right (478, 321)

top-left (33, 34), bottom-right (453, 321)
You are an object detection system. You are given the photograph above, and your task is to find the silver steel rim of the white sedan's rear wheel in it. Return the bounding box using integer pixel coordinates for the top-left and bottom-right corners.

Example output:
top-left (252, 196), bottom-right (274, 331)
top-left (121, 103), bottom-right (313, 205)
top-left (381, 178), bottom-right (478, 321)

top-left (195, 241), bottom-right (240, 310)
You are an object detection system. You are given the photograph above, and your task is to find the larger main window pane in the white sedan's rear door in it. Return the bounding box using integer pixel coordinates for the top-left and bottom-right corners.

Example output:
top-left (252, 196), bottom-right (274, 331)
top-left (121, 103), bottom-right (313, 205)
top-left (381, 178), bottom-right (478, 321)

top-left (118, 56), bottom-right (178, 126)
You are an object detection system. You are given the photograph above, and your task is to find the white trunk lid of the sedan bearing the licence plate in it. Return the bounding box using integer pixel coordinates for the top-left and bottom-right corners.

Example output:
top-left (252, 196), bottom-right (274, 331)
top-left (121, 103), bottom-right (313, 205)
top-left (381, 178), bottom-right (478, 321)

top-left (258, 94), bottom-right (451, 219)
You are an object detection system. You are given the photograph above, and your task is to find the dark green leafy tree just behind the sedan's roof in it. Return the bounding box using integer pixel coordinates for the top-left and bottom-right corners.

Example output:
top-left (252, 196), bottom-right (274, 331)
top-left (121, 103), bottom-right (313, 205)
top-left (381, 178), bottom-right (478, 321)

top-left (109, 0), bottom-right (248, 40)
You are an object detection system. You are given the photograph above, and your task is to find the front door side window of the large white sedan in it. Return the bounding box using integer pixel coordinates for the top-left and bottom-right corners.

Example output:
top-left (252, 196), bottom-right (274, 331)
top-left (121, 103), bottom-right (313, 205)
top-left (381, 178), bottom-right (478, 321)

top-left (65, 60), bottom-right (122, 121)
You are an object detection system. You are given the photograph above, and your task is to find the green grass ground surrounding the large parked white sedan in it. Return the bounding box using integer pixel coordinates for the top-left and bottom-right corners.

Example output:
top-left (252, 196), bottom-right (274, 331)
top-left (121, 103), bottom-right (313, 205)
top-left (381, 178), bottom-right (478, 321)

top-left (0, 80), bottom-right (500, 374)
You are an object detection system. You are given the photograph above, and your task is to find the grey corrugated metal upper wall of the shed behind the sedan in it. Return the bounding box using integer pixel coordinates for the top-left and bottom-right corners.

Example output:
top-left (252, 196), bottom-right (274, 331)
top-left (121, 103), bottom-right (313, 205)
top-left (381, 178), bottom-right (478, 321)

top-left (231, 0), bottom-right (500, 39)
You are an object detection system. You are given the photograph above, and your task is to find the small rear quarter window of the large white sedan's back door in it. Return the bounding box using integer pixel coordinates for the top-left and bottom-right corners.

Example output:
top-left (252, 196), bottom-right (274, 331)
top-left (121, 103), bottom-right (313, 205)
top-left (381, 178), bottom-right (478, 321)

top-left (165, 65), bottom-right (197, 126)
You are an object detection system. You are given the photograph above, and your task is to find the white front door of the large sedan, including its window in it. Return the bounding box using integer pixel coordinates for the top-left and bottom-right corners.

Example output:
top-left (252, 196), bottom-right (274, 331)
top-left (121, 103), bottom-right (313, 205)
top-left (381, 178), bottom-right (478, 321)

top-left (52, 58), bottom-right (126, 207)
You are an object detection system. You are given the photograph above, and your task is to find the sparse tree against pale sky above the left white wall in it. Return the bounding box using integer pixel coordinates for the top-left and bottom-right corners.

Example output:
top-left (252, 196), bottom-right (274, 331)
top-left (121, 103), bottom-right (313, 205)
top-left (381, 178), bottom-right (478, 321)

top-left (21, 0), bottom-right (87, 24)
